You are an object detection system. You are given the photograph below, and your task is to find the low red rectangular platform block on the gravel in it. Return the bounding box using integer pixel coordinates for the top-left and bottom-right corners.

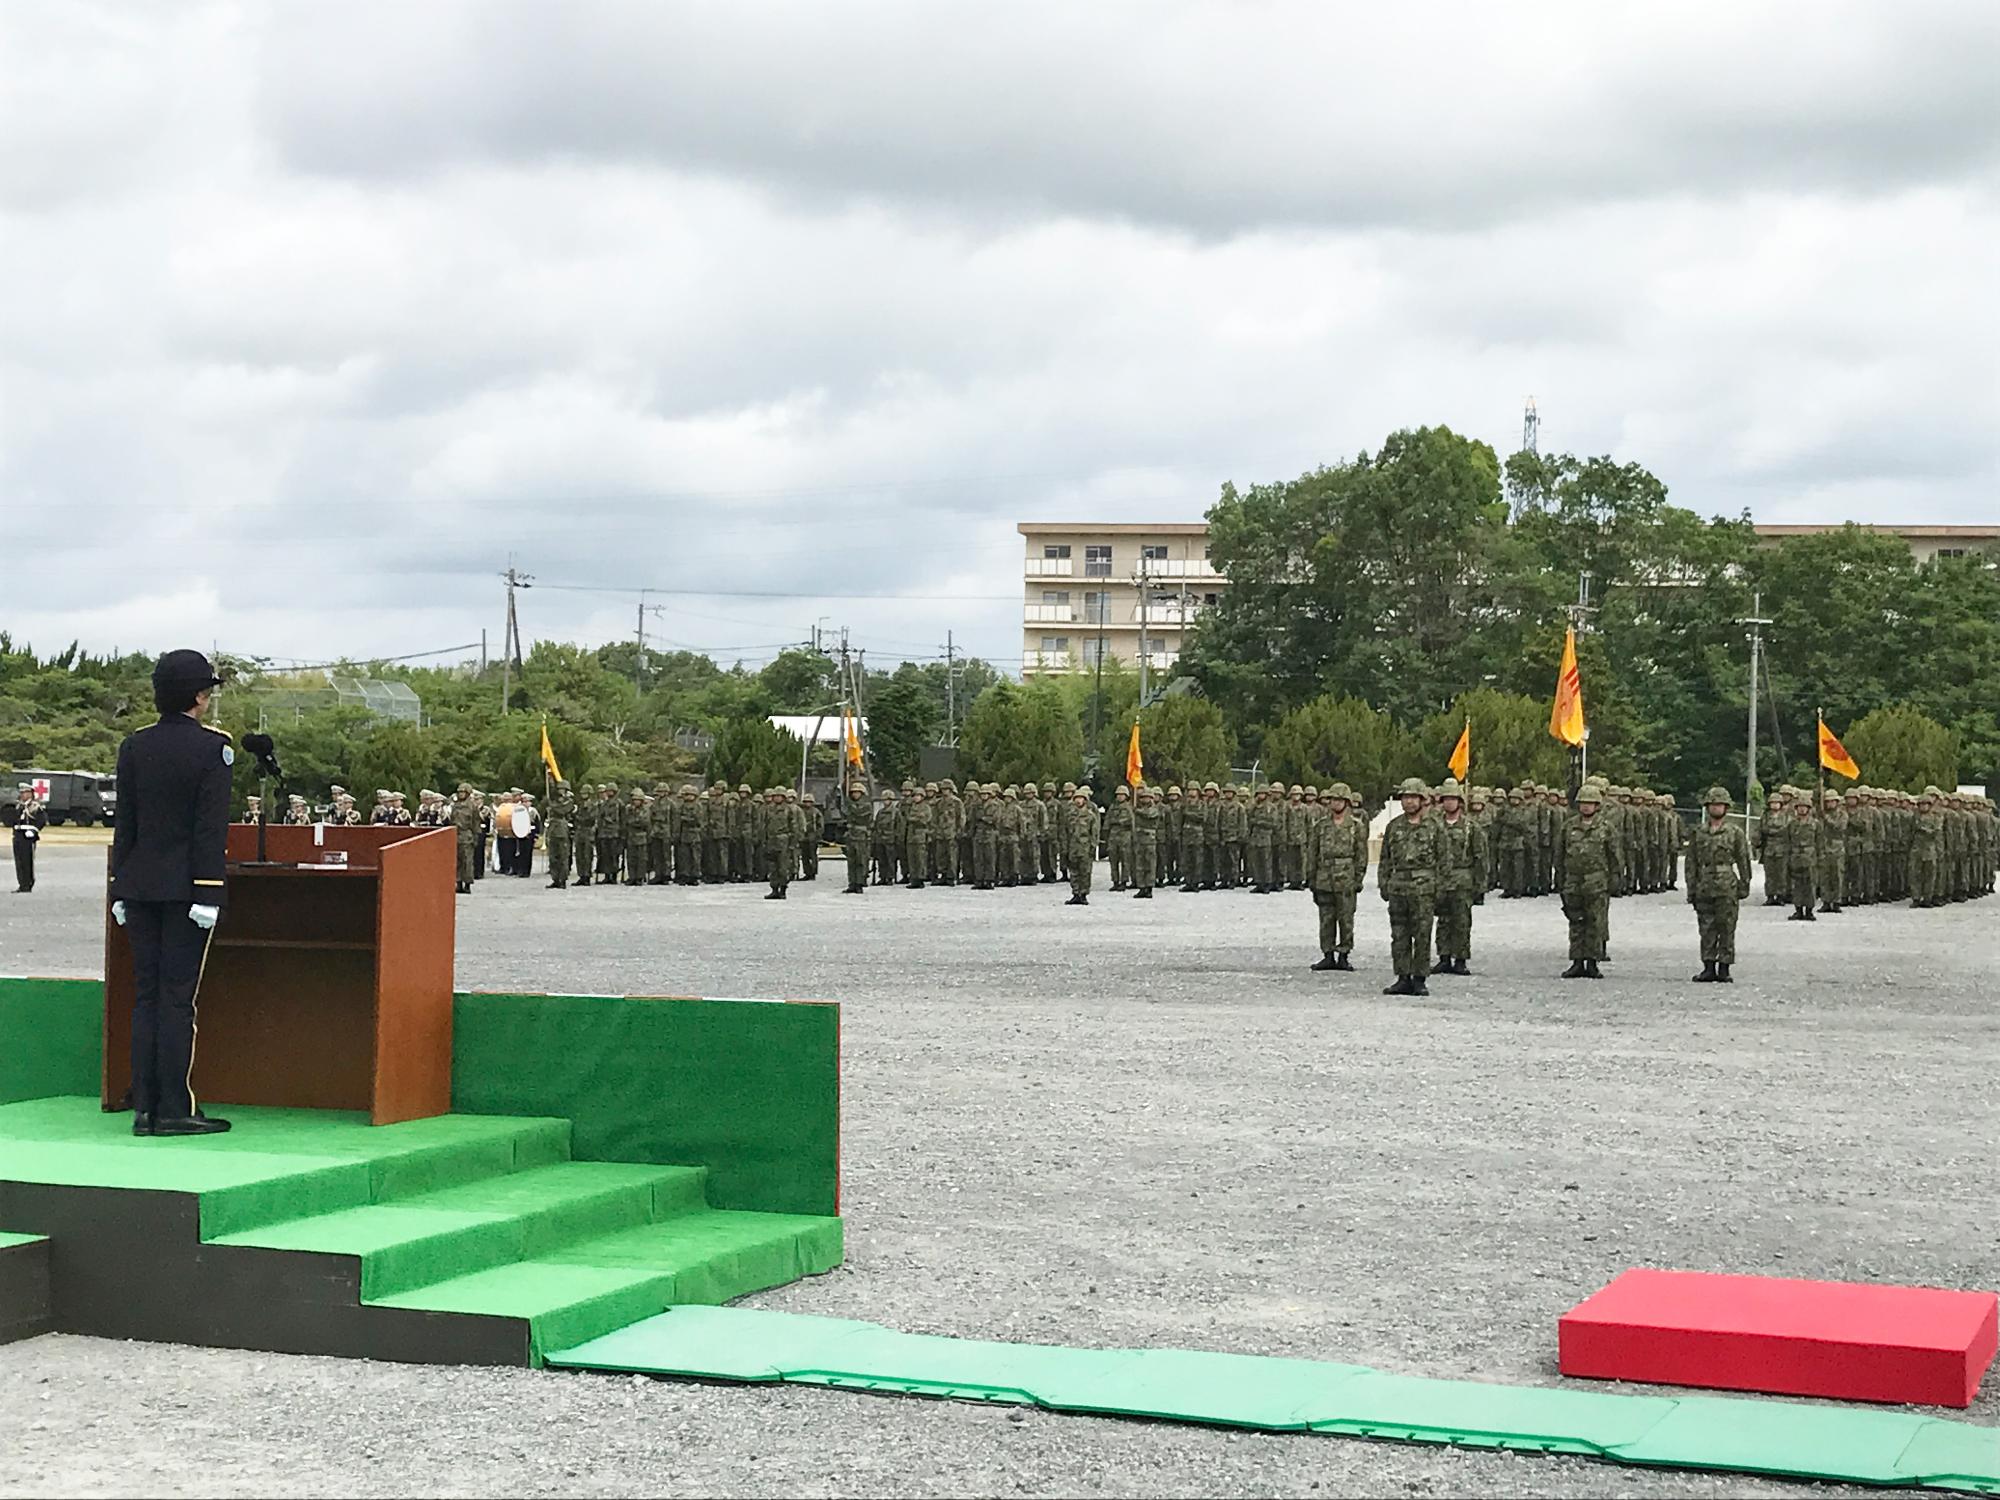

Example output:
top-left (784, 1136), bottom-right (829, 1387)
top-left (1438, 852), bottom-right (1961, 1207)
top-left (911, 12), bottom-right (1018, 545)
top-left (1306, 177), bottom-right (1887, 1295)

top-left (1556, 1270), bottom-right (2000, 1406)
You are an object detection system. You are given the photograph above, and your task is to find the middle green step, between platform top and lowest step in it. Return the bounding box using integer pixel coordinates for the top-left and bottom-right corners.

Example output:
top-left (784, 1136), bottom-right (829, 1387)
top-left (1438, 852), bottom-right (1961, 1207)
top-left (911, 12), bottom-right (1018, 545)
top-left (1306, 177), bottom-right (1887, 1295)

top-left (210, 1162), bottom-right (708, 1300)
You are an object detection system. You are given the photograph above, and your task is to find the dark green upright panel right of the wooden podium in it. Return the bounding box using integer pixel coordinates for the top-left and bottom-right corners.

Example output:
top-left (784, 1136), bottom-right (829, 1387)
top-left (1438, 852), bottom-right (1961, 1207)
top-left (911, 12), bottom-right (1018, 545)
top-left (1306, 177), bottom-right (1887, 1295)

top-left (452, 994), bottom-right (840, 1214)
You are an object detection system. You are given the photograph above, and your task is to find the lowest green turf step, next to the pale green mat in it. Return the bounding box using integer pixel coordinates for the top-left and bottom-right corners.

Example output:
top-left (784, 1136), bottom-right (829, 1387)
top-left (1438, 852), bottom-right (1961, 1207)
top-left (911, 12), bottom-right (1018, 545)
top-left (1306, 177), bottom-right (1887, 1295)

top-left (368, 1208), bottom-right (842, 1364)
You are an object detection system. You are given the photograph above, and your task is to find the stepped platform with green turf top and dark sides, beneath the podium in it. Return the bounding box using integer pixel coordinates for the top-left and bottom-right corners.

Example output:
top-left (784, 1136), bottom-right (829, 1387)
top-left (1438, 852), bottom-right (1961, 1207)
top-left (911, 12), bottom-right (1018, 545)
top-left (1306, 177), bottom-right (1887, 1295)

top-left (0, 1096), bottom-right (842, 1364)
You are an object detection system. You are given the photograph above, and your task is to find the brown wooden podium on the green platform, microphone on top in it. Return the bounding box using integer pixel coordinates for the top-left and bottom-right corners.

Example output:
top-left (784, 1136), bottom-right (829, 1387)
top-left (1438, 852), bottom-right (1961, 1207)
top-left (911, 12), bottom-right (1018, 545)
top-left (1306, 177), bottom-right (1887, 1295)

top-left (104, 824), bottom-right (458, 1124)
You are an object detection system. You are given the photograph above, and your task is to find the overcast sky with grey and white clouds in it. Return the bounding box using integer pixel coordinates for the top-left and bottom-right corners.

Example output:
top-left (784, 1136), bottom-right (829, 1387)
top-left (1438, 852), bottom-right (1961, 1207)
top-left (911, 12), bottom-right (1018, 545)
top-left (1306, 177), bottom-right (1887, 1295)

top-left (0, 0), bottom-right (2000, 666)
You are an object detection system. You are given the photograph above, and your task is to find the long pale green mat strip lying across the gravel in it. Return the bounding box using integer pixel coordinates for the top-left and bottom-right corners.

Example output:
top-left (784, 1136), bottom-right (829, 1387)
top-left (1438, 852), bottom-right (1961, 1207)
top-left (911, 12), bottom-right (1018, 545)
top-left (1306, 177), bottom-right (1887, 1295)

top-left (546, 1308), bottom-right (2000, 1494)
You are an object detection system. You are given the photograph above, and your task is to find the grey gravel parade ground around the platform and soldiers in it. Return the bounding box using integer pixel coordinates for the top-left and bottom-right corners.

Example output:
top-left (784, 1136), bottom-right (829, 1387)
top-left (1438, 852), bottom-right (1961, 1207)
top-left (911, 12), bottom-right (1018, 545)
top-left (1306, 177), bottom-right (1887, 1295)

top-left (0, 848), bottom-right (2000, 1496)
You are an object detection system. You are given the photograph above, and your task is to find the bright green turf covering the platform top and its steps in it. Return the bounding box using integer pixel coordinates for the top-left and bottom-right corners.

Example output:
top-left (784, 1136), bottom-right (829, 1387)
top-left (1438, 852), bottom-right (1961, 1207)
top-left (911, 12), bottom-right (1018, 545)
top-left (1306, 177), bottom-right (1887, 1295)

top-left (0, 1098), bottom-right (842, 1362)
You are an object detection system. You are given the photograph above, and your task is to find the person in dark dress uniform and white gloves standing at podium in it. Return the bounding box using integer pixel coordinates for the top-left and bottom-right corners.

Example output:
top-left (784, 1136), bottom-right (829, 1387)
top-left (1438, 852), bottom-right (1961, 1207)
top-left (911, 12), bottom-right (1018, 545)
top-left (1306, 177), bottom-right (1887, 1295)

top-left (112, 650), bottom-right (236, 1136)
